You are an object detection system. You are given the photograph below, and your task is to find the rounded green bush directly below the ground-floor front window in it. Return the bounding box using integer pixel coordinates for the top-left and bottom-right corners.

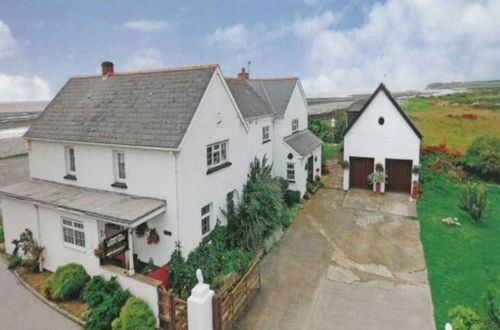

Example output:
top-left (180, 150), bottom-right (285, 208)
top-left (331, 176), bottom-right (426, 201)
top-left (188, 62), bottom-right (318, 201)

top-left (45, 263), bottom-right (90, 301)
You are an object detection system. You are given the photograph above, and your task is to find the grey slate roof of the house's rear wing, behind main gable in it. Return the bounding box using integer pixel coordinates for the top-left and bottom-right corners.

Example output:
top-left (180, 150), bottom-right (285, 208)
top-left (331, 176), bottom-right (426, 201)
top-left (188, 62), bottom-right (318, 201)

top-left (226, 77), bottom-right (298, 119)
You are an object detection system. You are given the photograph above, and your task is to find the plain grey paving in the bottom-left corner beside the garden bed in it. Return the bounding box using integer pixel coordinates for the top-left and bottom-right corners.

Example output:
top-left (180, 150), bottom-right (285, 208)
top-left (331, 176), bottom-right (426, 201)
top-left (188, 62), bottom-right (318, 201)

top-left (0, 260), bottom-right (82, 330)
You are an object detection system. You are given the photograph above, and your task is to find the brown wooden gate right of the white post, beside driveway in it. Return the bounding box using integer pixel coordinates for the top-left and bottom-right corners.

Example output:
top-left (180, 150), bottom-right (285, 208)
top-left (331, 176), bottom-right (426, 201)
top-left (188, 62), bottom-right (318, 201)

top-left (213, 257), bottom-right (260, 330)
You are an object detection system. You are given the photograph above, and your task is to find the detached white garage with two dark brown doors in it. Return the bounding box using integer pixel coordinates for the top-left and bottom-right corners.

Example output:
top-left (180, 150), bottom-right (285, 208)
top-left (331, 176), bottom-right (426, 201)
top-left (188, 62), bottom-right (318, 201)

top-left (344, 84), bottom-right (422, 193)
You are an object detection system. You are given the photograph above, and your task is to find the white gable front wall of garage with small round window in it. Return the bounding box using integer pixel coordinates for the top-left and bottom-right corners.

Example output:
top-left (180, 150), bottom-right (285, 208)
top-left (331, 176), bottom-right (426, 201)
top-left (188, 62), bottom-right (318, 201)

top-left (344, 91), bottom-right (420, 191)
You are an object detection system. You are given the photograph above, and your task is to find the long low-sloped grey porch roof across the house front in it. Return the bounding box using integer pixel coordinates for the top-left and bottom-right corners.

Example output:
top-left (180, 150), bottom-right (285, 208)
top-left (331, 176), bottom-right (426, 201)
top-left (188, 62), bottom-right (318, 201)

top-left (0, 179), bottom-right (166, 227)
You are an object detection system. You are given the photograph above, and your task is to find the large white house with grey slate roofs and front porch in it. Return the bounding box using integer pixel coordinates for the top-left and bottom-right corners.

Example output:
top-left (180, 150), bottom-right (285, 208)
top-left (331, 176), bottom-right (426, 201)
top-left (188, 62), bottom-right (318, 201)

top-left (0, 62), bottom-right (322, 284)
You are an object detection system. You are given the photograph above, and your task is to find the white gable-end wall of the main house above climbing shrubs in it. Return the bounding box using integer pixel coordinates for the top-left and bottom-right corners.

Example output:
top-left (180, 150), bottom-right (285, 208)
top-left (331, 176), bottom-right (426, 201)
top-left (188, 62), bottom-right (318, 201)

top-left (178, 71), bottom-right (250, 256)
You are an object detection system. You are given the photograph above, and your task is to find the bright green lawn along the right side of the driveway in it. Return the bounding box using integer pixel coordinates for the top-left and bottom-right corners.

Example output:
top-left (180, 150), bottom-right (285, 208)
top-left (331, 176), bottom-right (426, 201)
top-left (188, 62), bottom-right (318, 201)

top-left (418, 177), bottom-right (500, 329)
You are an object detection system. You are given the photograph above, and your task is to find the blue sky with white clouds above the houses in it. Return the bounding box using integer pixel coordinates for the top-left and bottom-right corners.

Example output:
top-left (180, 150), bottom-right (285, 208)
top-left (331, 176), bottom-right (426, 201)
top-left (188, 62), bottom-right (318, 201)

top-left (0, 0), bottom-right (500, 101)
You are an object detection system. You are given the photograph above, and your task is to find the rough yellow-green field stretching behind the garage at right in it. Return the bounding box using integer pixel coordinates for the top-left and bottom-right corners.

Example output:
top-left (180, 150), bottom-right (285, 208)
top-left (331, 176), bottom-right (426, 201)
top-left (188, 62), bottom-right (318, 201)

top-left (403, 90), bottom-right (500, 152)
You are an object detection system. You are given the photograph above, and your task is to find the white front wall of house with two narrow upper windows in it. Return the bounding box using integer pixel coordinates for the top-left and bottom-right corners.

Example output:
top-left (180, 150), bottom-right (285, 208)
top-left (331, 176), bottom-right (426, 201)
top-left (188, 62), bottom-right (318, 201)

top-left (29, 141), bottom-right (177, 265)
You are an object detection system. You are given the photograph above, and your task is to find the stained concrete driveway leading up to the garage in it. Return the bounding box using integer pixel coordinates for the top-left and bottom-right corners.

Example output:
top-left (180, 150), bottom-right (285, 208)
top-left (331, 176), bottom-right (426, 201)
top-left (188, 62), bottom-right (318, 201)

top-left (237, 189), bottom-right (435, 330)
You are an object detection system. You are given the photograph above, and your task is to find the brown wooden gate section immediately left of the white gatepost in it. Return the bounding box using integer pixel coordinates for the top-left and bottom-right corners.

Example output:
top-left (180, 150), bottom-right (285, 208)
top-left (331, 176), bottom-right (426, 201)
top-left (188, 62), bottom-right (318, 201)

top-left (158, 286), bottom-right (187, 330)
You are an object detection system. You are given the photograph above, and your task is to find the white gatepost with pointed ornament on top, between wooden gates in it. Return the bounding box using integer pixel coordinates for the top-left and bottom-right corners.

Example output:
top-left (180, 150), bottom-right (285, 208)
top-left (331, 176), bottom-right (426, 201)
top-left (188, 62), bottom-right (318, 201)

top-left (188, 269), bottom-right (214, 330)
